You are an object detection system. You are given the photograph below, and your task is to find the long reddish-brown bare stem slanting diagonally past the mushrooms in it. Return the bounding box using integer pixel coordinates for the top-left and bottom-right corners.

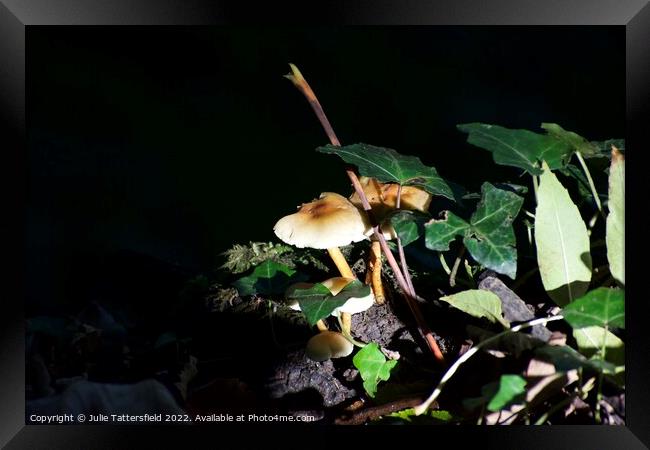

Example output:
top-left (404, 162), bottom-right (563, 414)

top-left (285, 64), bottom-right (444, 362)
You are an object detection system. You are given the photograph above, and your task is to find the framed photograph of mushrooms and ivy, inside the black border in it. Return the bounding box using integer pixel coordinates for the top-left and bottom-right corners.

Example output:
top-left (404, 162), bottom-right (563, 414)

top-left (24, 25), bottom-right (628, 427)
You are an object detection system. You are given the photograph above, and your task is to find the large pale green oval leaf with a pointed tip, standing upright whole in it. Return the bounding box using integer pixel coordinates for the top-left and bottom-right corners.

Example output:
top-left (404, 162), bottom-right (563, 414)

top-left (535, 165), bottom-right (591, 306)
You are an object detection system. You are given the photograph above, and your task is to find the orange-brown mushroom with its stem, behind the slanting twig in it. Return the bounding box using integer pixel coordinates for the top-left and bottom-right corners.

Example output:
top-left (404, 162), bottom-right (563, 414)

top-left (350, 177), bottom-right (432, 304)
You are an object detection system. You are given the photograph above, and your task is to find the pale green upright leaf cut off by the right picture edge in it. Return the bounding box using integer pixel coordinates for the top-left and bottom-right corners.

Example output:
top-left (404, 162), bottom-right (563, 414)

top-left (605, 153), bottom-right (625, 285)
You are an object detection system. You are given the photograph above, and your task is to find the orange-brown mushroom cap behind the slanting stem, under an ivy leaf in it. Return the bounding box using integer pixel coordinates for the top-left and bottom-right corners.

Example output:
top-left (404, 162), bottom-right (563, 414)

top-left (350, 177), bottom-right (432, 240)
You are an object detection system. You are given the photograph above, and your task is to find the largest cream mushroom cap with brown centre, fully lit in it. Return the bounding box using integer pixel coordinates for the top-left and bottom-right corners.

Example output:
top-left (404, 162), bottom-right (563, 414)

top-left (273, 192), bottom-right (369, 249)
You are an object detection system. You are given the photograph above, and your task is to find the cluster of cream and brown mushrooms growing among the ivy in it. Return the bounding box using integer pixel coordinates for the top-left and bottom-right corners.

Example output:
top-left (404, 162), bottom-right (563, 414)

top-left (273, 177), bottom-right (431, 361)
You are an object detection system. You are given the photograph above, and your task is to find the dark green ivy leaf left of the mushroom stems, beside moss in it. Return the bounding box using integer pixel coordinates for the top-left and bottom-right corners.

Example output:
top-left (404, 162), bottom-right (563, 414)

top-left (233, 259), bottom-right (306, 297)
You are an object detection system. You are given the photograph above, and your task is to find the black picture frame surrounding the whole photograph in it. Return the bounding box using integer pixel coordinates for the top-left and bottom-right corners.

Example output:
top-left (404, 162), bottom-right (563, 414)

top-left (0, 0), bottom-right (650, 450)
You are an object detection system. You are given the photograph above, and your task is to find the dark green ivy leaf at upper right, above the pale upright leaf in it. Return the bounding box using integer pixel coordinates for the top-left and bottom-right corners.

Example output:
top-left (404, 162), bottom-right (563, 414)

top-left (456, 123), bottom-right (573, 175)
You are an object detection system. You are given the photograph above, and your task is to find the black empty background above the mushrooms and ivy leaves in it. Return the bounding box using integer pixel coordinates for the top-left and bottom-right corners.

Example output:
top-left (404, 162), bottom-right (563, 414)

top-left (26, 26), bottom-right (625, 316)
